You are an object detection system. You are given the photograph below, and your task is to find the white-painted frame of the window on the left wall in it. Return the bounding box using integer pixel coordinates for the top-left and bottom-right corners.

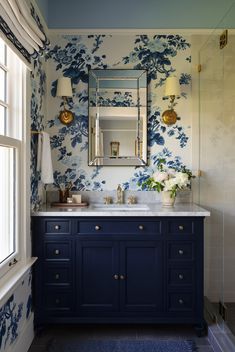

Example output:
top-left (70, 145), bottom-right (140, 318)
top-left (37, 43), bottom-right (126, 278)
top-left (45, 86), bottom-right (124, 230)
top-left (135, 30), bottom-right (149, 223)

top-left (0, 38), bottom-right (28, 279)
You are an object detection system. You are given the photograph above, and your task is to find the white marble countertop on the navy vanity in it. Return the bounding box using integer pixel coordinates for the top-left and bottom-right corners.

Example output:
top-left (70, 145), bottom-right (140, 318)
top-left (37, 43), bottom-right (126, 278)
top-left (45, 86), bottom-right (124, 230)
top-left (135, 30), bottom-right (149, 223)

top-left (31, 203), bottom-right (210, 217)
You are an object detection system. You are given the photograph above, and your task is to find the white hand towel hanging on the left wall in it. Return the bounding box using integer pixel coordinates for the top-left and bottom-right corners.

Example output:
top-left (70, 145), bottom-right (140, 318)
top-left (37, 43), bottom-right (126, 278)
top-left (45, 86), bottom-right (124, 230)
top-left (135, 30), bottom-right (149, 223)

top-left (37, 132), bottom-right (54, 184)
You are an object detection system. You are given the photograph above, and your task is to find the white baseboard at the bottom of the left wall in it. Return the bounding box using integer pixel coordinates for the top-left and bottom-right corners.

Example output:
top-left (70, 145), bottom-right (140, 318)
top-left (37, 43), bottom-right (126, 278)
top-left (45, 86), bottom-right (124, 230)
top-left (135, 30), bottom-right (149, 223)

top-left (6, 314), bottom-right (34, 352)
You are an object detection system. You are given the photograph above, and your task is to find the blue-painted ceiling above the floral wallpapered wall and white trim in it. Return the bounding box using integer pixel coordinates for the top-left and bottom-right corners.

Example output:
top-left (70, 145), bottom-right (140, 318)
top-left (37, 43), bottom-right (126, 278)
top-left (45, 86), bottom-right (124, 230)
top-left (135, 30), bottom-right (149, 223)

top-left (36, 0), bottom-right (235, 29)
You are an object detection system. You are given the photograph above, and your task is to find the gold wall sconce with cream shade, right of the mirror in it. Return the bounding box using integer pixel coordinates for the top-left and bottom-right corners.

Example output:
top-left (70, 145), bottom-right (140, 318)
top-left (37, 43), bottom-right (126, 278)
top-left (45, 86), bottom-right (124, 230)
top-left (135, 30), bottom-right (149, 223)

top-left (162, 76), bottom-right (180, 126)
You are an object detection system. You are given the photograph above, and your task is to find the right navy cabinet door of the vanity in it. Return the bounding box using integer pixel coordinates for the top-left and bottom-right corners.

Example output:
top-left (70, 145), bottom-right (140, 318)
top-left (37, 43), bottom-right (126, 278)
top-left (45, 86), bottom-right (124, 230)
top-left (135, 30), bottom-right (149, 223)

top-left (119, 240), bottom-right (164, 315)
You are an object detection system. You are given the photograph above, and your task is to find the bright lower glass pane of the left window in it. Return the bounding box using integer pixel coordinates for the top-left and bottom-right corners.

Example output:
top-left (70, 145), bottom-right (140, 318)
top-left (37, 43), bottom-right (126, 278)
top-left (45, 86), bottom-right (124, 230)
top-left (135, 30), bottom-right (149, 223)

top-left (0, 146), bottom-right (15, 263)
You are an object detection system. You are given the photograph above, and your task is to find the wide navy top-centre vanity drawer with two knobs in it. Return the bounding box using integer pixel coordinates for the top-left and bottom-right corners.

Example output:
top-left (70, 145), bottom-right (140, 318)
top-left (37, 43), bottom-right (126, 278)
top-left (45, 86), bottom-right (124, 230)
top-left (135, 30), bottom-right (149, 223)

top-left (77, 219), bottom-right (161, 235)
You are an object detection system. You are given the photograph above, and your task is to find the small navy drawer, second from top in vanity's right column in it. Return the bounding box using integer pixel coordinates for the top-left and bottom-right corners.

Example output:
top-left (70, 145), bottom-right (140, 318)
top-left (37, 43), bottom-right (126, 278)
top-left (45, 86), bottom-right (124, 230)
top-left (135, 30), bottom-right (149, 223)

top-left (168, 241), bottom-right (194, 260)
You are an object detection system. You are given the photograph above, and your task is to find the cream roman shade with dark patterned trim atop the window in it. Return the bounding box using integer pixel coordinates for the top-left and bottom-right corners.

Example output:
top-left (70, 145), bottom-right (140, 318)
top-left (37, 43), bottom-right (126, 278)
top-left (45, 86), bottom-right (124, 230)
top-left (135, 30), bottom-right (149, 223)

top-left (0, 0), bottom-right (49, 63)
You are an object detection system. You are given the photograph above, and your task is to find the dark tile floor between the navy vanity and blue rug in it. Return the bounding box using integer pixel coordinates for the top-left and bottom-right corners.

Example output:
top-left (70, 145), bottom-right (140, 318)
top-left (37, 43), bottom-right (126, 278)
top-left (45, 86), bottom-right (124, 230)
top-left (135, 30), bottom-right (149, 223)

top-left (28, 325), bottom-right (214, 352)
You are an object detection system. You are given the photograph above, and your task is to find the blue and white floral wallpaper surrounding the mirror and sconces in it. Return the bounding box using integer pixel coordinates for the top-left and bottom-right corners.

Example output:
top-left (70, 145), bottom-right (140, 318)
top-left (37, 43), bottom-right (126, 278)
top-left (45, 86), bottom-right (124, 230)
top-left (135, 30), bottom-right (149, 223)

top-left (32, 34), bottom-right (192, 202)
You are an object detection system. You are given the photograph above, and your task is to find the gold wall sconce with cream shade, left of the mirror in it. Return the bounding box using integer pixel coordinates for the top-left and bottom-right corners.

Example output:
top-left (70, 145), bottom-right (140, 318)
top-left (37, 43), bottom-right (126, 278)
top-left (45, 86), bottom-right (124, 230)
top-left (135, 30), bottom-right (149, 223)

top-left (56, 77), bottom-right (74, 125)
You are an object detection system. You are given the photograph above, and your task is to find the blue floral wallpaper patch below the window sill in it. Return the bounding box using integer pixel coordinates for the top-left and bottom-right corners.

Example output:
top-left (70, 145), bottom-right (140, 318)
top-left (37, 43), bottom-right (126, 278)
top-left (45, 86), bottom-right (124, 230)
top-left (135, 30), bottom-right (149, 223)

top-left (0, 270), bottom-right (32, 352)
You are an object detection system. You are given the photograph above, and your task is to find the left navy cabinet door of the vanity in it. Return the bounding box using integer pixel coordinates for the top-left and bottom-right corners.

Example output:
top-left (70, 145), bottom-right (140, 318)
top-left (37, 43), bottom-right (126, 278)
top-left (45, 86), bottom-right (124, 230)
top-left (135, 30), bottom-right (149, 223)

top-left (77, 239), bottom-right (119, 316)
